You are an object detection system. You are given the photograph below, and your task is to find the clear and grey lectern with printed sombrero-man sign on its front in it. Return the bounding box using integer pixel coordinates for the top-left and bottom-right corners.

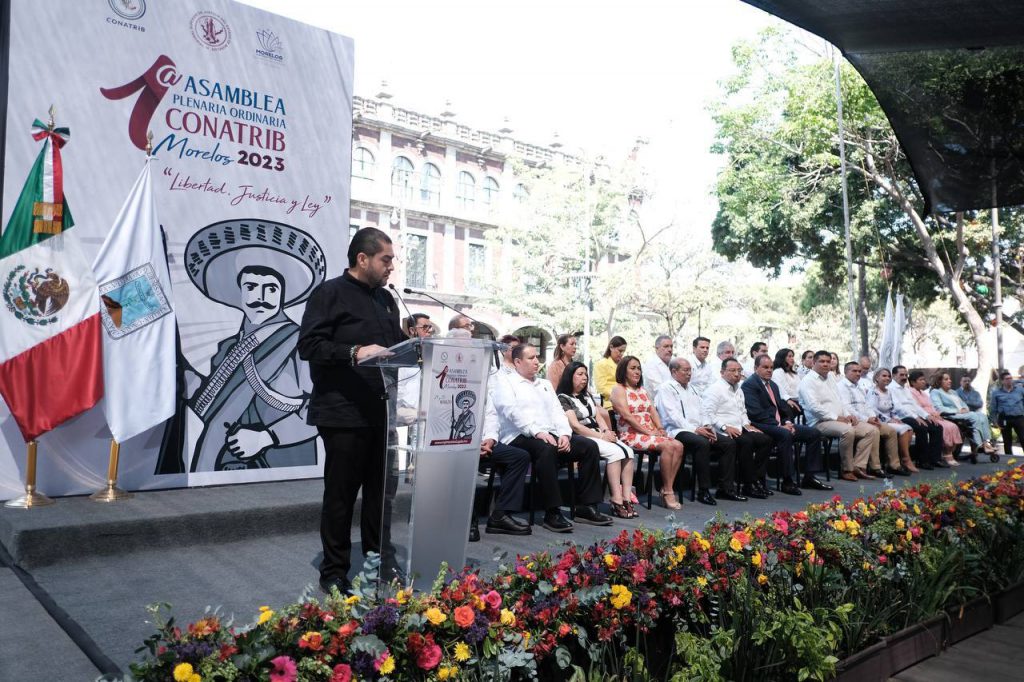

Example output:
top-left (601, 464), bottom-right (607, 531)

top-left (360, 338), bottom-right (497, 589)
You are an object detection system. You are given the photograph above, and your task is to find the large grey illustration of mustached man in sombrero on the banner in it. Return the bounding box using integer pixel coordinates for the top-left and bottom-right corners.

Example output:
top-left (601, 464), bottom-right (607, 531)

top-left (169, 219), bottom-right (327, 472)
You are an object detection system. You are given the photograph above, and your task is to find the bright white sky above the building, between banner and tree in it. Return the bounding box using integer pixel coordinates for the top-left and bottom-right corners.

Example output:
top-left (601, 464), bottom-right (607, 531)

top-left (242, 0), bottom-right (778, 233)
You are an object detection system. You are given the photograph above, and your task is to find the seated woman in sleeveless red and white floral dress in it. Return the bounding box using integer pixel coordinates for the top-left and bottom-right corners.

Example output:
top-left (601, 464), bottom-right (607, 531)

top-left (611, 355), bottom-right (683, 509)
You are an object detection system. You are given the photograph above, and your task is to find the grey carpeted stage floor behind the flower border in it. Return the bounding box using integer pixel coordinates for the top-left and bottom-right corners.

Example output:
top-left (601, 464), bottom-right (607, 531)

top-left (0, 458), bottom-right (1007, 682)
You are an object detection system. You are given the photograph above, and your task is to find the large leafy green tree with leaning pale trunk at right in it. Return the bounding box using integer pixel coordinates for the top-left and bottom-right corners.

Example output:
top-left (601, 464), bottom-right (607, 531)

top-left (713, 30), bottom-right (1024, 393)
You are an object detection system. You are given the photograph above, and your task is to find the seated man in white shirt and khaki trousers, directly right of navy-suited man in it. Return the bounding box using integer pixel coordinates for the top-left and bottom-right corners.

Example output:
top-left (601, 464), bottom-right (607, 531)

top-left (800, 350), bottom-right (879, 480)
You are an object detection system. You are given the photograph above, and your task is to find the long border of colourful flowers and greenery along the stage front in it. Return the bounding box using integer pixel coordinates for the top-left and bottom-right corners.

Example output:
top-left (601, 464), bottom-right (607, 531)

top-left (132, 468), bottom-right (1024, 682)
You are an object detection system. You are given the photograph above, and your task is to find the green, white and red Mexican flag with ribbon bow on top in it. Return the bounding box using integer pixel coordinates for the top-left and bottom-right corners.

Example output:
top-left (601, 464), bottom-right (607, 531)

top-left (0, 120), bottom-right (103, 441)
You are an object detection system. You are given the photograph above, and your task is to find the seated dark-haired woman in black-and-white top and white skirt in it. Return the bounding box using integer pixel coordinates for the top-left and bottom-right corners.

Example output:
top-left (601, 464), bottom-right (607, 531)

top-left (555, 363), bottom-right (638, 518)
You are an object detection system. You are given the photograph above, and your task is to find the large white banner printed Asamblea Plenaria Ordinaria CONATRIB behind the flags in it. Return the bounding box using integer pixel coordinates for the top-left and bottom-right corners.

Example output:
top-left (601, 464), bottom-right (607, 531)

top-left (0, 0), bottom-right (353, 500)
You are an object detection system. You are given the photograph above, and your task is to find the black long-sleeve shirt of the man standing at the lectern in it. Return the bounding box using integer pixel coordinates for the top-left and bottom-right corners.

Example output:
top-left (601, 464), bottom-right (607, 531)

top-left (297, 270), bottom-right (406, 428)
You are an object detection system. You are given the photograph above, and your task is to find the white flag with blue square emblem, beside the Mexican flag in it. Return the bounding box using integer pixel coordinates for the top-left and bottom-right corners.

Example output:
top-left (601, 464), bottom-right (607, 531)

top-left (92, 158), bottom-right (175, 442)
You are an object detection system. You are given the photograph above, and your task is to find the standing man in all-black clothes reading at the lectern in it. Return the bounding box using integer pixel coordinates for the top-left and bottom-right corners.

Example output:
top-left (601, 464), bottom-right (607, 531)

top-left (297, 227), bottom-right (406, 593)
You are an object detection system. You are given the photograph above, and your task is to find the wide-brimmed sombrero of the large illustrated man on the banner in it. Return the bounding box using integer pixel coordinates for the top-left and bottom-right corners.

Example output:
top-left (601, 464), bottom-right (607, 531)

top-left (184, 218), bottom-right (327, 307)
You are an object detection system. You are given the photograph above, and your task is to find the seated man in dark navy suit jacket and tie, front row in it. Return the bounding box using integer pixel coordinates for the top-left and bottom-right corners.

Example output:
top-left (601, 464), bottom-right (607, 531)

top-left (742, 355), bottom-right (833, 495)
